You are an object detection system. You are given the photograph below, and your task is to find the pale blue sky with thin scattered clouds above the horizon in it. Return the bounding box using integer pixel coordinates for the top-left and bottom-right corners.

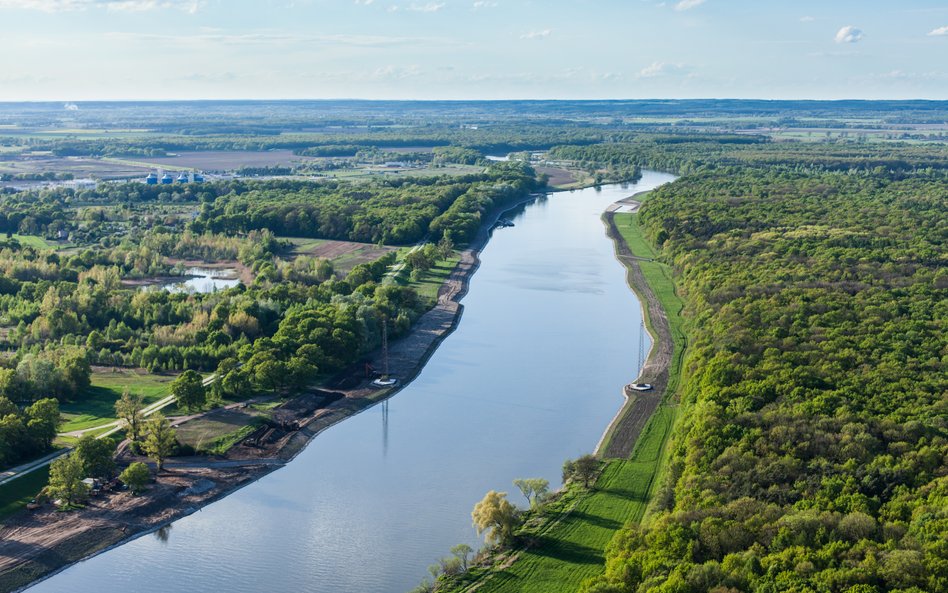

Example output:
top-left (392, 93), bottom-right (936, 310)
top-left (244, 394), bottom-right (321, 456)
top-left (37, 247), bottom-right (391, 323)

top-left (0, 0), bottom-right (948, 101)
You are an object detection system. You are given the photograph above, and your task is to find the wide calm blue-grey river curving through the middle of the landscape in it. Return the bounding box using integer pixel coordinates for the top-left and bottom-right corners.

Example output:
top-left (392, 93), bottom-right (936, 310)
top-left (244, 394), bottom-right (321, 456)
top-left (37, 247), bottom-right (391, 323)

top-left (31, 172), bottom-right (673, 593)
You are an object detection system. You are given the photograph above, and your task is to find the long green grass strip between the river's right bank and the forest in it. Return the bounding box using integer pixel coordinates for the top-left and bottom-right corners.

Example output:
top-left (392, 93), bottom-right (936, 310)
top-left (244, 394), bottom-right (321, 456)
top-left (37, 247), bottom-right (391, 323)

top-left (447, 207), bottom-right (686, 593)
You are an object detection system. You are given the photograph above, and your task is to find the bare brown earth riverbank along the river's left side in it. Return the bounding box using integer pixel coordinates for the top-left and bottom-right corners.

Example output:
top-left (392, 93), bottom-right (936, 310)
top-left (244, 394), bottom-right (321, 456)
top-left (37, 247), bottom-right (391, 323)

top-left (0, 194), bottom-right (536, 592)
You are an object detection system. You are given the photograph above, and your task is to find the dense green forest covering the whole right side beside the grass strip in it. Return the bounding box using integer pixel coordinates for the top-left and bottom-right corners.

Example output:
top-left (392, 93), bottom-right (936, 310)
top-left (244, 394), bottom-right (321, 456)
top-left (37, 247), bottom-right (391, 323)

top-left (580, 155), bottom-right (948, 593)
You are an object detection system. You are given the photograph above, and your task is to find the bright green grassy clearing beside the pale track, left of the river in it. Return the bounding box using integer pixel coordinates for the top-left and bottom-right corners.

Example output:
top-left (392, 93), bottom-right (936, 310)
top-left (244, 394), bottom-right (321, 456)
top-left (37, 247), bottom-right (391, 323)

top-left (59, 369), bottom-right (174, 432)
